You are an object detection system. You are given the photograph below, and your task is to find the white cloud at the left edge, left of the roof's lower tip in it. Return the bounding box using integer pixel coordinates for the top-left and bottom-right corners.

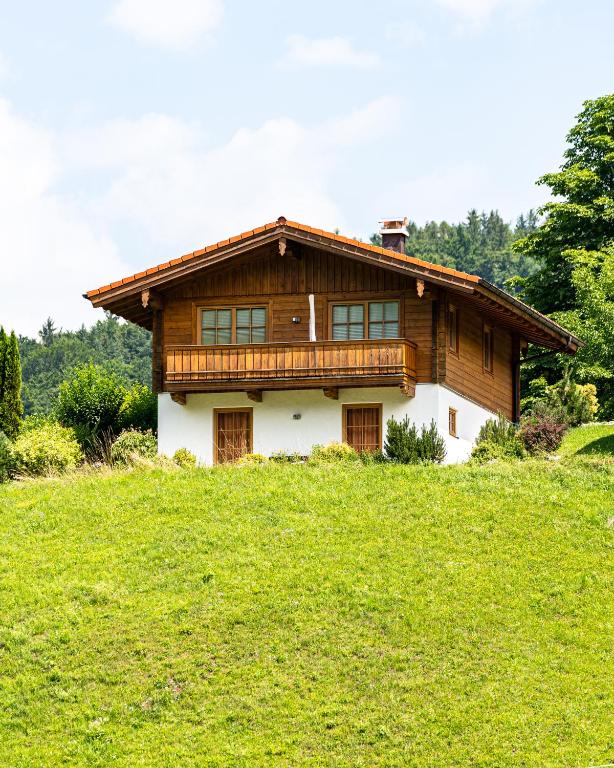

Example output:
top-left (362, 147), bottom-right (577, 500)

top-left (0, 100), bottom-right (127, 334)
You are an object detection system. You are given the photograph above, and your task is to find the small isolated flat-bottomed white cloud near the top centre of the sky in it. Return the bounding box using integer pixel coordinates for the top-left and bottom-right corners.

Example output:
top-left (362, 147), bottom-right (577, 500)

top-left (278, 35), bottom-right (381, 71)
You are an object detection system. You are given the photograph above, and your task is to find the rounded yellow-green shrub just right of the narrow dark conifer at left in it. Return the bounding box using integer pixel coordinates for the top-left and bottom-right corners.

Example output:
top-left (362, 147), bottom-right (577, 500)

top-left (12, 421), bottom-right (83, 476)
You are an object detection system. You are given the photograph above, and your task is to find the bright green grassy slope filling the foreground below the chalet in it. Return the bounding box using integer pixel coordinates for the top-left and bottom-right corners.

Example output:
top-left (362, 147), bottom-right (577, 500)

top-left (0, 427), bottom-right (614, 768)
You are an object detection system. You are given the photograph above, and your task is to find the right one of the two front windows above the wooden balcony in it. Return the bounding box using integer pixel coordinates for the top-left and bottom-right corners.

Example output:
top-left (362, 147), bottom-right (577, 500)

top-left (331, 301), bottom-right (399, 341)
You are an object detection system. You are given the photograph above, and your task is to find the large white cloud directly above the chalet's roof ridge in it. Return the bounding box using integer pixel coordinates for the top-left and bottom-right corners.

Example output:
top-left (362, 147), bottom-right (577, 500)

top-left (65, 98), bottom-right (398, 258)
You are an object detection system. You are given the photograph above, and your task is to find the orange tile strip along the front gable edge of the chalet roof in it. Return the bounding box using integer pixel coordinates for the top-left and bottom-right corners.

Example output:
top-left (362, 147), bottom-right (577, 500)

top-left (85, 216), bottom-right (480, 299)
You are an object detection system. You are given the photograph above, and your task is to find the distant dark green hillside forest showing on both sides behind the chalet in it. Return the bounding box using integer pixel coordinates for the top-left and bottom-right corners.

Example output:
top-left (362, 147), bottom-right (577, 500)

top-left (19, 210), bottom-right (537, 414)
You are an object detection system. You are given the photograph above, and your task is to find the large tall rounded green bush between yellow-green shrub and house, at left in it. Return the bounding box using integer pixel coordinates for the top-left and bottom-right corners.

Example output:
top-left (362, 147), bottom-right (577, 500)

top-left (56, 364), bottom-right (126, 449)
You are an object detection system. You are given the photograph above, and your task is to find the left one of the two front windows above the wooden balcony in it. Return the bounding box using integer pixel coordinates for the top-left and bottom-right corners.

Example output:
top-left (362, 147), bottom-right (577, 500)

top-left (200, 307), bottom-right (266, 344)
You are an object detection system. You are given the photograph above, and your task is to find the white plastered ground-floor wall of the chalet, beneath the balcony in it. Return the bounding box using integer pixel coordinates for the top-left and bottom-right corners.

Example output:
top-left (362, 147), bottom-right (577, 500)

top-left (158, 384), bottom-right (493, 464)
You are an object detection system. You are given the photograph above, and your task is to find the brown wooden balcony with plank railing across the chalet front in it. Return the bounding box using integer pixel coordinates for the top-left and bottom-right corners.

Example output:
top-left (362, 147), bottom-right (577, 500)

top-left (164, 339), bottom-right (416, 396)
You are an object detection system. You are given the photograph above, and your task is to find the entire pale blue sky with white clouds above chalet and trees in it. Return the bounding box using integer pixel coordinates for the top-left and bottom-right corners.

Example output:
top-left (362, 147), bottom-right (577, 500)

top-left (0, 0), bottom-right (614, 335)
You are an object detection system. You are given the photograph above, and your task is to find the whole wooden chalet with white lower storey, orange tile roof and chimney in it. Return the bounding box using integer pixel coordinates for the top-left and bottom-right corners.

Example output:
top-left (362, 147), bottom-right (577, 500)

top-left (86, 217), bottom-right (580, 464)
